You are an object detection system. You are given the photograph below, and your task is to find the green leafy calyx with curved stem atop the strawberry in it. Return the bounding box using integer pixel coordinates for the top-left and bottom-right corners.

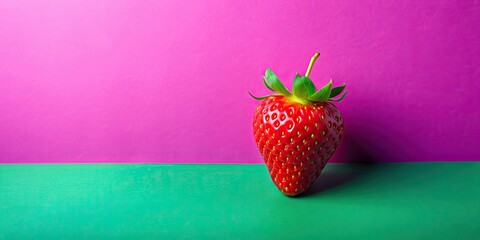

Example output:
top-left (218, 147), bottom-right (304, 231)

top-left (249, 53), bottom-right (347, 104)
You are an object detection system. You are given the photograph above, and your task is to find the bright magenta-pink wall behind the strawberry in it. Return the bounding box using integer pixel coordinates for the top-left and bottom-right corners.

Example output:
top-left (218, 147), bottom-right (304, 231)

top-left (0, 0), bottom-right (480, 163)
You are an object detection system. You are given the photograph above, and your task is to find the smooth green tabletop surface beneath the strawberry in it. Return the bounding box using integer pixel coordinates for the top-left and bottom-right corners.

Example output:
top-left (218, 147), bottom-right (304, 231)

top-left (0, 162), bottom-right (480, 239)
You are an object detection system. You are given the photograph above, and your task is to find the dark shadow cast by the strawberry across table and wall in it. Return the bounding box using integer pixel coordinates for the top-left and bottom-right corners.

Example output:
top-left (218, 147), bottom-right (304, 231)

top-left (298, 104), bottom-right (418, 197)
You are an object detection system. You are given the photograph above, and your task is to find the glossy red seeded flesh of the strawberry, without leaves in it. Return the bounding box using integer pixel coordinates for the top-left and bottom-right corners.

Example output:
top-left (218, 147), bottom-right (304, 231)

top-left (253, 96), bottom-right (343, 196)
